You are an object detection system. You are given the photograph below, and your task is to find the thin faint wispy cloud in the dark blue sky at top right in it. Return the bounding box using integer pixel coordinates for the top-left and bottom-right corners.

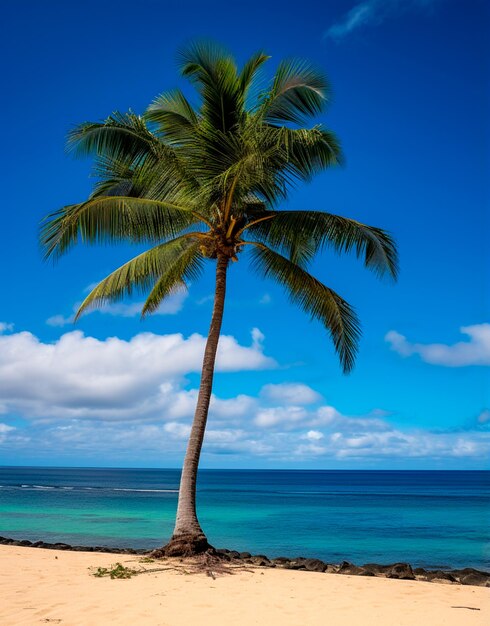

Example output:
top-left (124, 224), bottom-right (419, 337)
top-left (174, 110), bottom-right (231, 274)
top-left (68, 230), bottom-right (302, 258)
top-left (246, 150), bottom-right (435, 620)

top-left (325, 0), bottom-right (438, 40)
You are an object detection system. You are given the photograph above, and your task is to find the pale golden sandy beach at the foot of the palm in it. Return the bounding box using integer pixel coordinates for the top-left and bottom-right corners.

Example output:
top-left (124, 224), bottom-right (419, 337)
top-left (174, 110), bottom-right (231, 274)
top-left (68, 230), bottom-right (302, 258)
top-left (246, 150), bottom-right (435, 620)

top-left (0, 546), bottom-right (490, 626)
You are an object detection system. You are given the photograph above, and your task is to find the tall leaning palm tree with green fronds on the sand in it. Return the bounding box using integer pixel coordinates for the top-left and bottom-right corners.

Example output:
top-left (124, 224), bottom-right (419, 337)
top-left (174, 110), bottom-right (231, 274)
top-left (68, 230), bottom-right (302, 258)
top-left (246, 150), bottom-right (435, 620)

top-left (41, 43), bottom-right (397, 555)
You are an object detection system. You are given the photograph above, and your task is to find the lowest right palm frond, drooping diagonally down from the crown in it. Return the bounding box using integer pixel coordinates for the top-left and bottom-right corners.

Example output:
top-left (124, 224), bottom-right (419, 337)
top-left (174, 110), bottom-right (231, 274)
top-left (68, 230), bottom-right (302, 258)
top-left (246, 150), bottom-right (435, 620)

top-left (250, 242), bottom-right (360, 373)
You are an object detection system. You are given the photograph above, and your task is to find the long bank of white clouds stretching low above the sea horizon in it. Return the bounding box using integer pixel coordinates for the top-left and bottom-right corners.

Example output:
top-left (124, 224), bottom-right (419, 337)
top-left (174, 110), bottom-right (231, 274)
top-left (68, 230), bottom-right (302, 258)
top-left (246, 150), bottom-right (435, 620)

top-left (0, 327), bottom-right (490, 467)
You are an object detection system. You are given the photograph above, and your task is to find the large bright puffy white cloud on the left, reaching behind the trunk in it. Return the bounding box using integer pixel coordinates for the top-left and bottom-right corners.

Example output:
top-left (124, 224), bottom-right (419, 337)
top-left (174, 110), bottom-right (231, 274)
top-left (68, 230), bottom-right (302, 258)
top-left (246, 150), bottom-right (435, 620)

top-left (0, 329), bottom-right (275, 420)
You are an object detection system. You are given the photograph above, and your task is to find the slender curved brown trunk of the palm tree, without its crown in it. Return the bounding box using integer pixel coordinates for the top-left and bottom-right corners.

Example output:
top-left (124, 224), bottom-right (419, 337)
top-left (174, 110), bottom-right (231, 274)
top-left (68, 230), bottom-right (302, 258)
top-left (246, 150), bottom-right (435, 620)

top-left (163, 255), bottom-right (229, 556)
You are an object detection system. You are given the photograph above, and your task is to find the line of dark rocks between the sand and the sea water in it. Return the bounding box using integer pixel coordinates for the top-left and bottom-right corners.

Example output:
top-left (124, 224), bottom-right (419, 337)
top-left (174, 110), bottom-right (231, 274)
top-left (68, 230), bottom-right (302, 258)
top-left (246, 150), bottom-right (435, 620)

top-left (0, 537), bottom-right (490, 587)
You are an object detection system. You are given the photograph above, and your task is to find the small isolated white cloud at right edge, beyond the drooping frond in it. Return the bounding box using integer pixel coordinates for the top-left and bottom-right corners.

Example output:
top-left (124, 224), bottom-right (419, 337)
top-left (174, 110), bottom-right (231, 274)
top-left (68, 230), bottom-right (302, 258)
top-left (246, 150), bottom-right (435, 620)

top-left (385, 324), bottom-right (490, 367)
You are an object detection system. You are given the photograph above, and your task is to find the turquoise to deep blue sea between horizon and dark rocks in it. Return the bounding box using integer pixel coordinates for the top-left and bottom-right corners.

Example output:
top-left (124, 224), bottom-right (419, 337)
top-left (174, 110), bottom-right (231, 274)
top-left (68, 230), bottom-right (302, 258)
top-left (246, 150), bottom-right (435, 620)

top-left (0, 467), bottom-right (490, 570)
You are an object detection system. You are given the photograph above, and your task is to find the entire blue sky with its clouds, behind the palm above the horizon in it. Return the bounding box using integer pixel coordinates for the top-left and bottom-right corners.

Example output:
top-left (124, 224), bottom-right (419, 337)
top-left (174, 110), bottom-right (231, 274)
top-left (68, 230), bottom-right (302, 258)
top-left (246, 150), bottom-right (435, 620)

top-left (0, 0), bottom-right (490, 469)
